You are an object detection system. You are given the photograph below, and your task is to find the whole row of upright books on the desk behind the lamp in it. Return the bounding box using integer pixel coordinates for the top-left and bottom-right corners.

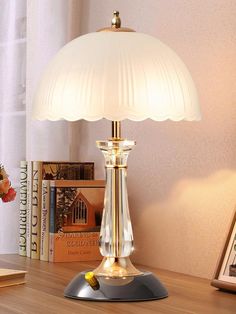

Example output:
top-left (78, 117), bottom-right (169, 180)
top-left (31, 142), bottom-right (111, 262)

top-left (19, 161), bottom-right (105, 262)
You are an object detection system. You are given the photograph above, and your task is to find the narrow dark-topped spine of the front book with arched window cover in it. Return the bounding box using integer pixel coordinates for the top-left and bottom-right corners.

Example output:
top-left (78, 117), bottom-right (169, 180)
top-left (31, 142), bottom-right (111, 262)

top-left (48, 181), bottom-right (56, 262)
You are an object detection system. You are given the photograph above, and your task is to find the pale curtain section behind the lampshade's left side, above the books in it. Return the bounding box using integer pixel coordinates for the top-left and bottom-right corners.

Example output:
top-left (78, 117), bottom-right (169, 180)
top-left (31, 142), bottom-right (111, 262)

top-left (26, 0), bottom-right (80, 160)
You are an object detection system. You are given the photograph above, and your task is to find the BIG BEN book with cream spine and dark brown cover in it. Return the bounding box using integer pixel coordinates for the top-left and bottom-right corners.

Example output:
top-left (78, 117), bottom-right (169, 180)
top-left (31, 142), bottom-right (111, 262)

top-left (31, 161), bottom-right (94, 259)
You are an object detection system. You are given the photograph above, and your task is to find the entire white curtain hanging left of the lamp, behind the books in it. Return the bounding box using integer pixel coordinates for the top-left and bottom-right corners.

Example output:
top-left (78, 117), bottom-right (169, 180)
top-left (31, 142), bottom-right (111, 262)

top-left (0, 0), bottom-right (80, 254)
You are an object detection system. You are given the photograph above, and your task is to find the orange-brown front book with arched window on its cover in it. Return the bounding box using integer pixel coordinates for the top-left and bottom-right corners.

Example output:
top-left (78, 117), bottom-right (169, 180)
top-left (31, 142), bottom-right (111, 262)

top-left (49, 180), bottom-right (105, 262)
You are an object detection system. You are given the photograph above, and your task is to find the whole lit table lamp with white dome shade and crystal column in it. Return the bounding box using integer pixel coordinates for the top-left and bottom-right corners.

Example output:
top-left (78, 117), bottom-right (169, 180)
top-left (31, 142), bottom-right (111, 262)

top-left (33, 11), bottom-right (200, 301)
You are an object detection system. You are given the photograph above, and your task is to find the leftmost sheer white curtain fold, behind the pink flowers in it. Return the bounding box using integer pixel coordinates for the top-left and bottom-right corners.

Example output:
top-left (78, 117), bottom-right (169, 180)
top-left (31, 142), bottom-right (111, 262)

top-left (0, 0), bottom-right (26, 253)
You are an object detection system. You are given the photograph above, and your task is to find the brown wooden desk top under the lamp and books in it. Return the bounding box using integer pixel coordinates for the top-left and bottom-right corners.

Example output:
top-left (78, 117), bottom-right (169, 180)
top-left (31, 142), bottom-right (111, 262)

top-left (0, 255), bottom-right (236, 314)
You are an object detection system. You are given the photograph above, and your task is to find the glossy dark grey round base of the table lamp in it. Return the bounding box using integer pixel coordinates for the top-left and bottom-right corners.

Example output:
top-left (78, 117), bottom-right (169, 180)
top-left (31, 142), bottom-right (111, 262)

top-left (64, 272), bottom-right (168, 302)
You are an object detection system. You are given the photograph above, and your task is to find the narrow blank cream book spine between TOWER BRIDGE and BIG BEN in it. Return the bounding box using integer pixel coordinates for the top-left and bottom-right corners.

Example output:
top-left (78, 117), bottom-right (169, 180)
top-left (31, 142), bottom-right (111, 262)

top-left (26, 161), bottom-right (32, 257)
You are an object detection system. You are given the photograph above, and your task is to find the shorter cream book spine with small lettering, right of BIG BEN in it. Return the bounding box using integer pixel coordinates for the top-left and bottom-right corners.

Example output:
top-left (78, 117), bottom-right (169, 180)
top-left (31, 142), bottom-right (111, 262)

top-left (40, 180), bottom-right (50, 261)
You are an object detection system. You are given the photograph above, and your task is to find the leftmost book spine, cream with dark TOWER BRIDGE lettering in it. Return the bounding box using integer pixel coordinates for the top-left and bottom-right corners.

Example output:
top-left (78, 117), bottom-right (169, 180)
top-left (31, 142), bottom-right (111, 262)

top-left (19, 160), bottom-right (27, 256)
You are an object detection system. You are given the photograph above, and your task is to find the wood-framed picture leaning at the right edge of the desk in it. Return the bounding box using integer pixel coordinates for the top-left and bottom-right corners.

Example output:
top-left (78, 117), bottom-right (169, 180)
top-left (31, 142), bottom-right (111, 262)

top-left (211, 213), bottom-right (236, 292)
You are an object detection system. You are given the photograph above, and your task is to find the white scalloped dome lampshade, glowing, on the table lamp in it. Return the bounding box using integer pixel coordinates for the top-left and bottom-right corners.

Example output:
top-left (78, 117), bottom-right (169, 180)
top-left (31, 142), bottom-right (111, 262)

top-left (33, 32), bottom-right (200, 121)
